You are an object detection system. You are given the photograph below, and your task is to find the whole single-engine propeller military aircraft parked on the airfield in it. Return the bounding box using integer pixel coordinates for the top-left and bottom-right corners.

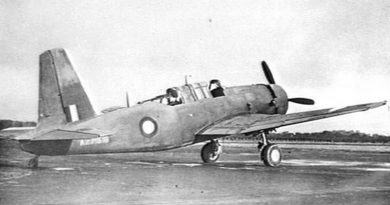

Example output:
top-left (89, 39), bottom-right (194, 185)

top-left (2, 48), bottom-right (386, 167)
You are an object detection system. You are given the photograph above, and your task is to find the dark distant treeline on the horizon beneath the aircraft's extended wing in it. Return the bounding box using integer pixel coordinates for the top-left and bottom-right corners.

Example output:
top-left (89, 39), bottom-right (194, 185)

top-left (228, 130), bottom-right (390, 143)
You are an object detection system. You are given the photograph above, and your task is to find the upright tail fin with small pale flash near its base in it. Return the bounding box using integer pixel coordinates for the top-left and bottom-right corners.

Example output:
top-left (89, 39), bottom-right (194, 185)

top-left (38, 48), bottom-right (95, 127)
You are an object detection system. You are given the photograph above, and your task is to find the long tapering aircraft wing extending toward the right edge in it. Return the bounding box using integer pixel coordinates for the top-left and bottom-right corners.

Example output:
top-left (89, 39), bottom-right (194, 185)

top-left (196, 101), bottom-right (386, 139)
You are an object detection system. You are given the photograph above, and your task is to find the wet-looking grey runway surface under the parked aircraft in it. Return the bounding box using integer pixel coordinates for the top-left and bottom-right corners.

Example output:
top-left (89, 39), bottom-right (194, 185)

top-left (0, 141), bottom-right (390, 205)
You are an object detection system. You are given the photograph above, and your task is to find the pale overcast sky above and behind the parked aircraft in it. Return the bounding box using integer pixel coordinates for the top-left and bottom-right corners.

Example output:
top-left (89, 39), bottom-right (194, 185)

top-left (0, 0), bottom-right (390, 135)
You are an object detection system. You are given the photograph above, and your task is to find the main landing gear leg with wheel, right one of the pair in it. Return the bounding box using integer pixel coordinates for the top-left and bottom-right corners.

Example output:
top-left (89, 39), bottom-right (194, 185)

top-left (257, 132), bottom-right (282, 167)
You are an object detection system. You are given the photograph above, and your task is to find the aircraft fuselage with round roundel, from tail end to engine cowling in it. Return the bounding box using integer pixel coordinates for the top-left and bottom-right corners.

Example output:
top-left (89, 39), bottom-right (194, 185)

top-left (20, 84), bottom-right (288, 155)
